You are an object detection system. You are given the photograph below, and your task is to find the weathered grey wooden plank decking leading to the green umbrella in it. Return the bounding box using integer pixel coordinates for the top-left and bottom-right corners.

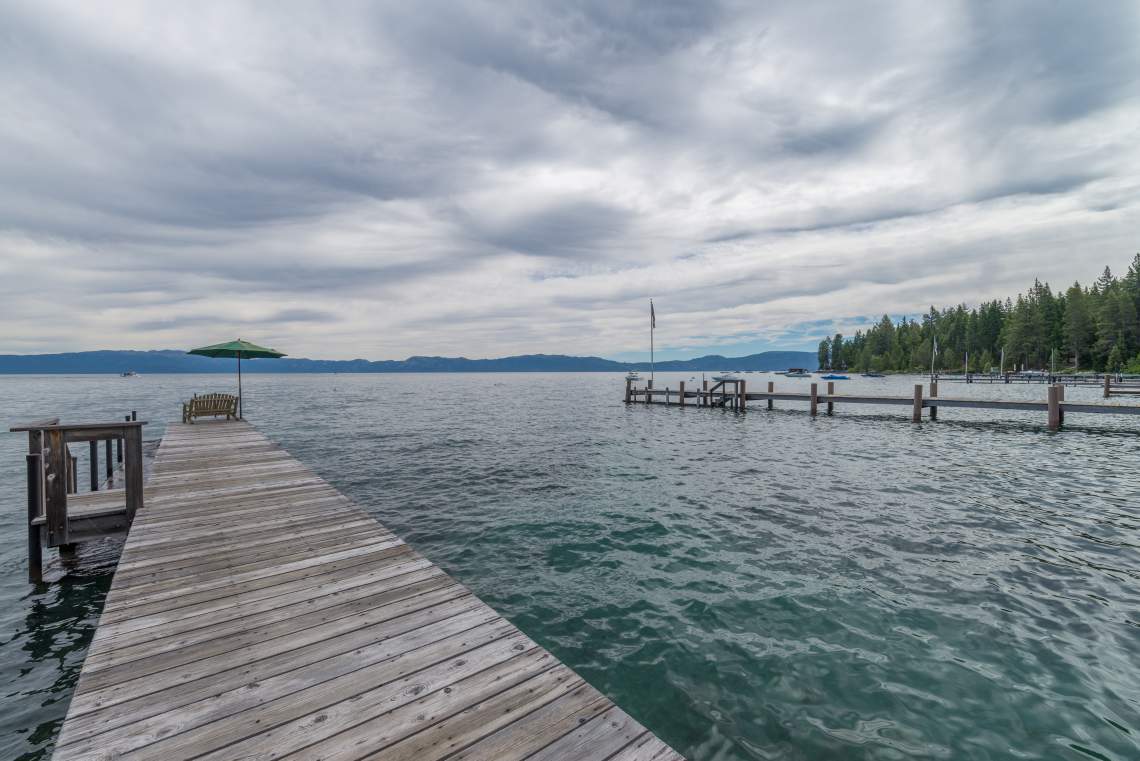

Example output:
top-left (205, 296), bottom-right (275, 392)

top-left (54, 422), bottom-right (681, 761)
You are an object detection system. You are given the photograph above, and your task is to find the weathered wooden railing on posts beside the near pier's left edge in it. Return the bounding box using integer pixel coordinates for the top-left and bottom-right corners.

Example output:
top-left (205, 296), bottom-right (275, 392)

top-left (10, 414), bottom-right (146, 582)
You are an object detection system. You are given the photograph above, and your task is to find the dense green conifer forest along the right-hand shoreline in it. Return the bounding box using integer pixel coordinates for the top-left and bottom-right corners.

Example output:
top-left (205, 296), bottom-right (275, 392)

top-left (819, 254), bottom-right (1140, 373)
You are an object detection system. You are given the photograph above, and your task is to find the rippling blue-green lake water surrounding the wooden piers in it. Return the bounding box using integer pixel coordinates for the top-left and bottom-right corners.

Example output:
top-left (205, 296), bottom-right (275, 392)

top-left (0, 374), bottom-right (1140, 761)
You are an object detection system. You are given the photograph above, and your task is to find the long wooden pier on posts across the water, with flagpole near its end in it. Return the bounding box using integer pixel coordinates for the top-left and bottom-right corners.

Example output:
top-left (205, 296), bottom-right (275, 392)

top-left (625, 379), bottom-right (1140, 431)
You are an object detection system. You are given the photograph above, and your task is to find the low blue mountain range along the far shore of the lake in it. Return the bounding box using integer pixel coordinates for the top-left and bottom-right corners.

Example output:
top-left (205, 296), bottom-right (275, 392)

top-left (0, 349), bottom-right (817, 375)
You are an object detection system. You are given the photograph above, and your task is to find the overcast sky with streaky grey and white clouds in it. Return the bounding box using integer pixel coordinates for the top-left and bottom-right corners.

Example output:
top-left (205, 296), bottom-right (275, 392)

top-left (0, 0), bottom-right (1140, 359)
